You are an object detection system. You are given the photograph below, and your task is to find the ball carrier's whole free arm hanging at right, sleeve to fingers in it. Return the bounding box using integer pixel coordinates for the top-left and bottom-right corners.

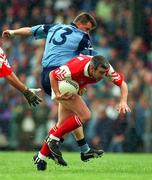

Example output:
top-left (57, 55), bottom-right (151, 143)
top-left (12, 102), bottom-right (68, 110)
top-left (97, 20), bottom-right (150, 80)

top-left (106, 65), bottom-right (131, 113)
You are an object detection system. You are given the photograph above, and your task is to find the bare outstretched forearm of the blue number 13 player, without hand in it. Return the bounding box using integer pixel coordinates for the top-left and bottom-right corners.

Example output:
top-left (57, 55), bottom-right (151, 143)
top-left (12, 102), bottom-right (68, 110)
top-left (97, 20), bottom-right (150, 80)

top-left (11, 27), bottom-right (32, 36)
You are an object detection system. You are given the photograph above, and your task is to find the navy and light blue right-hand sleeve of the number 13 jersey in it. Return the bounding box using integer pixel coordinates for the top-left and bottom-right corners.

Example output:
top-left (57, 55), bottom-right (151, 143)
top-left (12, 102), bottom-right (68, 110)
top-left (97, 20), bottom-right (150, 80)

top-left (78, 34), bottom-right (98, 56)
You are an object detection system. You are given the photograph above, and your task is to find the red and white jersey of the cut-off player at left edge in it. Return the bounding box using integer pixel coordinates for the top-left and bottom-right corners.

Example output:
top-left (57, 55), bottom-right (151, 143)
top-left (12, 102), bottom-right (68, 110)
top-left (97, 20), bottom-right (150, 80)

top-left (0, 48), bottom-right (13, 78)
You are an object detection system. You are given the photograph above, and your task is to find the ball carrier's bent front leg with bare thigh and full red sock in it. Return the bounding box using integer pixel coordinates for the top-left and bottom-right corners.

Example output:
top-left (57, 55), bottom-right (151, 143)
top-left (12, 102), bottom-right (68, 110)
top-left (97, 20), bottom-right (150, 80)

top-left (48, 95), bottom-right (91, 156)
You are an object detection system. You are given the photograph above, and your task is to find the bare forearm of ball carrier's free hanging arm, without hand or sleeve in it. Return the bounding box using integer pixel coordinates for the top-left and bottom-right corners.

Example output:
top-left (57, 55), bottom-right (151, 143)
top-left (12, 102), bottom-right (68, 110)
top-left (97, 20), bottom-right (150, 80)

top-left (120, 81), bottom-right (128, 103)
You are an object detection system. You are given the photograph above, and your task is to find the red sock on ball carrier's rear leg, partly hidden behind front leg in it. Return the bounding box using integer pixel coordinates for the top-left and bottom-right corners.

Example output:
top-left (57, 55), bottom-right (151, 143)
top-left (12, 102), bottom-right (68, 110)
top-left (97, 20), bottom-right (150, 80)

top-left (40, 125), bottom-right (58, 157)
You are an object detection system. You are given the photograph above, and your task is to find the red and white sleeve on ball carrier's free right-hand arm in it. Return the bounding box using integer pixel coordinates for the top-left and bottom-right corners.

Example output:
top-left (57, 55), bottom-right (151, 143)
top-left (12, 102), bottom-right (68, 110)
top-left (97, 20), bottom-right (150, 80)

top-left (106, 65), bottom-right (124, 86)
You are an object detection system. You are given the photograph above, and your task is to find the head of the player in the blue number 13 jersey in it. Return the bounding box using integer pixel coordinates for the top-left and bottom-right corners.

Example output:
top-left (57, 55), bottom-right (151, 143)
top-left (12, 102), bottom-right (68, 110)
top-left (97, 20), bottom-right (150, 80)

top-left (73, 12), bottom-right (96, 33)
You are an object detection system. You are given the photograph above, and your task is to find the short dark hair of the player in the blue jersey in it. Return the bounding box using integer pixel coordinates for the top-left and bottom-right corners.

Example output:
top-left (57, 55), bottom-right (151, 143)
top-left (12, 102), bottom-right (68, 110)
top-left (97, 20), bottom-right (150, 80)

top-left (73, 12), bottom-right (97, 29)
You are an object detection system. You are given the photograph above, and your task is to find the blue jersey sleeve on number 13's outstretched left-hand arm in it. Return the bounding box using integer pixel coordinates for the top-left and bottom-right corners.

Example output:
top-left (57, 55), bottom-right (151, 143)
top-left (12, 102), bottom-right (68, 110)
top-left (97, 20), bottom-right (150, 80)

top-left (31, 24), bottom-right (56, 39)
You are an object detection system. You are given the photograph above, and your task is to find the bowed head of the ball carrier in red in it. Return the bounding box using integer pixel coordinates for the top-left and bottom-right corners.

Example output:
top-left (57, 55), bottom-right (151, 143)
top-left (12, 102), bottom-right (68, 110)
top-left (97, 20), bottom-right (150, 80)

top-left (89, 56), bottom-right (110, 79)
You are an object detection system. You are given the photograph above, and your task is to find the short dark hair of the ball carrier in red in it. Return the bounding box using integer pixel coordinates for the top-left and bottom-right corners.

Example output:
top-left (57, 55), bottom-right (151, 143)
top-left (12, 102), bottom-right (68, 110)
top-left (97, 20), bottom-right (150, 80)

top-left (90, 55), bottom-right (110, 70)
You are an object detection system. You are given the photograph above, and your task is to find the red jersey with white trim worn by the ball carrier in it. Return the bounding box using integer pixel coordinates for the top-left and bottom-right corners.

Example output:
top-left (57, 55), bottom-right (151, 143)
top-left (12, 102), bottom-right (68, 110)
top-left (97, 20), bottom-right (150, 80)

top-left (52, 55), bottom-right (123, 88)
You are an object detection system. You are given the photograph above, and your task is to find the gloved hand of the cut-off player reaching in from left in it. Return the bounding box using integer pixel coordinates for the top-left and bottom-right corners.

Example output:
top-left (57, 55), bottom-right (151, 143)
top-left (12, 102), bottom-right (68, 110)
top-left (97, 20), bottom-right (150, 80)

top-left (23, 88), bottom-right (42, 107)
